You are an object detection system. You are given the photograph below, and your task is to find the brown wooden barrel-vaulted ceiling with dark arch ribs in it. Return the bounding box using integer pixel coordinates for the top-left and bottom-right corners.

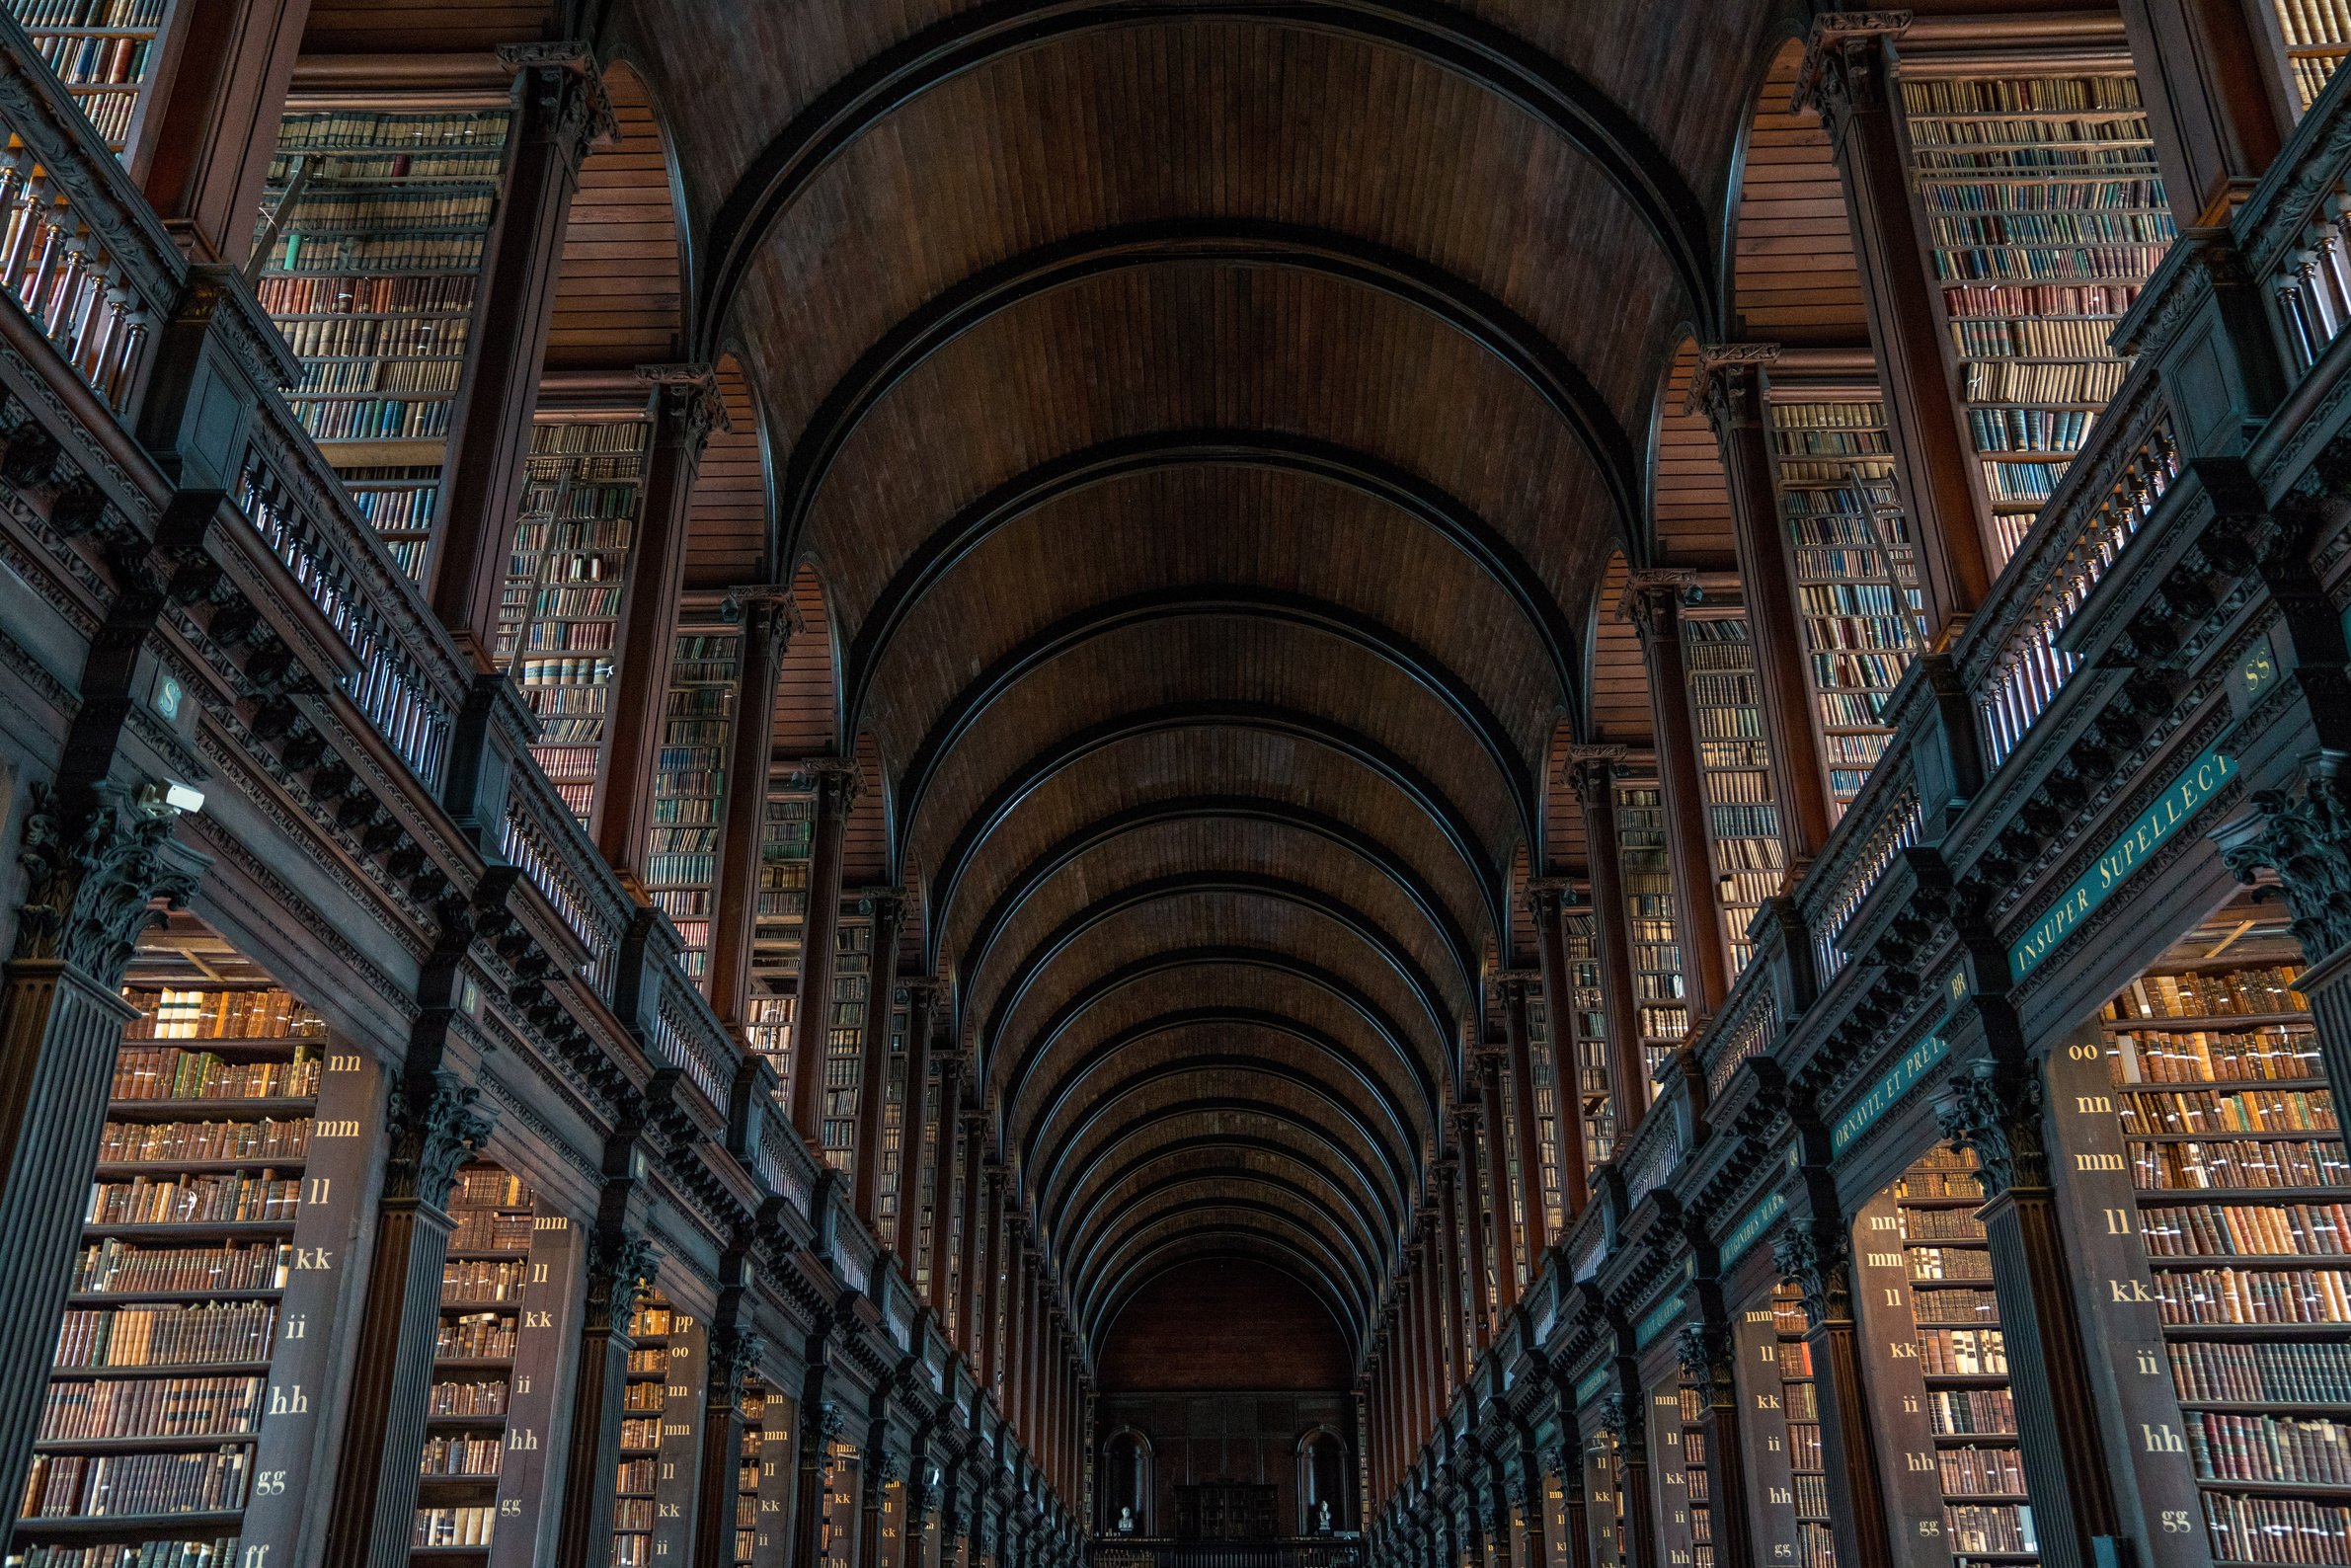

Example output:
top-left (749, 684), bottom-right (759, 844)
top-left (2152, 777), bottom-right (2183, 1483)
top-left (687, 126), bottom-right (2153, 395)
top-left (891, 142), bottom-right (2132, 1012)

top-left (313, 0), bottom-right (1837, 1352)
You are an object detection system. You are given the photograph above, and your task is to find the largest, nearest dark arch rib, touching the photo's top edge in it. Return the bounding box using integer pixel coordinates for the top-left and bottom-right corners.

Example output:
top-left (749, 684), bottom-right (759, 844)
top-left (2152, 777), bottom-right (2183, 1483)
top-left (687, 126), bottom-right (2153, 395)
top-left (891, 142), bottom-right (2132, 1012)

top-left (696, 0), bottom-right (1719, 357)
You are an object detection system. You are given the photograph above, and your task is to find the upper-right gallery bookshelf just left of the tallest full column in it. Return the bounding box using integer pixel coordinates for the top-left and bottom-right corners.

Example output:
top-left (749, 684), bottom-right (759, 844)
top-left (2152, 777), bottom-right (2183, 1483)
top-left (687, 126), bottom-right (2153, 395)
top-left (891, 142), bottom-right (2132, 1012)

top-left (1770, 385), bottom-right (1920, 814)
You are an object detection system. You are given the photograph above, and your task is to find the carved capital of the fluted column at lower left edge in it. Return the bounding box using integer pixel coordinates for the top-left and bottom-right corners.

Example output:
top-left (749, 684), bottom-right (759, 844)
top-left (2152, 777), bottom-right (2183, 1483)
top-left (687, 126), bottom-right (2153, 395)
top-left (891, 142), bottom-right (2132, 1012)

top-left (14, 783), bottom-right (204, 989)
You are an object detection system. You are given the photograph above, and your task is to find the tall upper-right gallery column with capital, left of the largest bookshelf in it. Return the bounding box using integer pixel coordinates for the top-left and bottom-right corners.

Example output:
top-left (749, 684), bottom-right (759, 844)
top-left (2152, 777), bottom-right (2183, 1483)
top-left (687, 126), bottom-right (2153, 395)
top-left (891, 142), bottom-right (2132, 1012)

top-left (1794, 12), bottom-right (1994, 649)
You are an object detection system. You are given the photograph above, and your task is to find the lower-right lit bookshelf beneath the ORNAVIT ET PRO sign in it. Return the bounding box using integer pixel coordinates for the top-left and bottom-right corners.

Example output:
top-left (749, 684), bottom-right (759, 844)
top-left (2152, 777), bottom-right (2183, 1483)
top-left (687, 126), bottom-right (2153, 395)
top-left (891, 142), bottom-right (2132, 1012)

top-left (1893, 1147), bottom-right (2038, 1563)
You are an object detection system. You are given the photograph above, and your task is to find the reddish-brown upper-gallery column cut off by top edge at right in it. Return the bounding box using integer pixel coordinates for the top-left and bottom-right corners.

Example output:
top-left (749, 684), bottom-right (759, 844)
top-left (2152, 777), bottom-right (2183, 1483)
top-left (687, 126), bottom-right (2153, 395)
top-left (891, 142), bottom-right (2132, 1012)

top-left (2125, 0), bottom-right (2297, 223)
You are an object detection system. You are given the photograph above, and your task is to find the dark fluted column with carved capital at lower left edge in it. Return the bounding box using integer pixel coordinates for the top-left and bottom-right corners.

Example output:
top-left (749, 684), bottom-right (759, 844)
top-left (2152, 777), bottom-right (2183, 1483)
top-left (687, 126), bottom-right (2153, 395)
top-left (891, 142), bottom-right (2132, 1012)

top-left (0, 789), bottom-right (204, 1500)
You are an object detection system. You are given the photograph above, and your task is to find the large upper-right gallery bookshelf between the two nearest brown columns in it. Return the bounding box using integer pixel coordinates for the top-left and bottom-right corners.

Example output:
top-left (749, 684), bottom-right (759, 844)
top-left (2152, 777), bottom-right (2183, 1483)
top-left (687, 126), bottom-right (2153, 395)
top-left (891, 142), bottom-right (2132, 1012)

top-left (1902, 70), bottom-right (2177, 571)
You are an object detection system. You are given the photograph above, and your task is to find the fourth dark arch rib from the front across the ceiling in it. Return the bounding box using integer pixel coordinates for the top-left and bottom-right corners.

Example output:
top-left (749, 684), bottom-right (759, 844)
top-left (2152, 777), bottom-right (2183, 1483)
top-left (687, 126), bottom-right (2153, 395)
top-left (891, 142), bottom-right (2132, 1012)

top-left (899, 586), bottom-right (1535, 869)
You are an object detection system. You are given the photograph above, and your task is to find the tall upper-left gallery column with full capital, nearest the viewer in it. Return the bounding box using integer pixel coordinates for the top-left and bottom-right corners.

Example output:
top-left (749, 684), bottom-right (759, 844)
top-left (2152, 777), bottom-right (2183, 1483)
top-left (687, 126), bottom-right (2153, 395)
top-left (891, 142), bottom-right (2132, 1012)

top-left (428, 42), bottom-right (618, 670)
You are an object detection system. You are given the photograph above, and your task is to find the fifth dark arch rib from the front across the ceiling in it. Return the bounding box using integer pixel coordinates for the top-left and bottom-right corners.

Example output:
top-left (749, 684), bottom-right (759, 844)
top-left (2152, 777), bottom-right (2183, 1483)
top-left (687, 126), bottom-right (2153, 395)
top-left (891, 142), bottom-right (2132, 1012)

top-left (921, 700), bottom-right (1502, 945)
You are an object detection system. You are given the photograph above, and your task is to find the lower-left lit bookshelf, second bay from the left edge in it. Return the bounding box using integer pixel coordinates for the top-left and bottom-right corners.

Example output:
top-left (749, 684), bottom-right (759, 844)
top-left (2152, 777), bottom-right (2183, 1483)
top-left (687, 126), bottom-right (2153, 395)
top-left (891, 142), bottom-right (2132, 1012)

top-left (409, 1164), bottom-right (533, 1563)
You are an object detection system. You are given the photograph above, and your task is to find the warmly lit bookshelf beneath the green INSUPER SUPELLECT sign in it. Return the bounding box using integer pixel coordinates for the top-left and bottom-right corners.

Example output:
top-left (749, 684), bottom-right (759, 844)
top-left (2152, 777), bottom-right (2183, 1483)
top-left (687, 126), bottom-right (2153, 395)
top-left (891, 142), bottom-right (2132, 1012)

top-left (2099, 905), bottom-right (2351, 1563)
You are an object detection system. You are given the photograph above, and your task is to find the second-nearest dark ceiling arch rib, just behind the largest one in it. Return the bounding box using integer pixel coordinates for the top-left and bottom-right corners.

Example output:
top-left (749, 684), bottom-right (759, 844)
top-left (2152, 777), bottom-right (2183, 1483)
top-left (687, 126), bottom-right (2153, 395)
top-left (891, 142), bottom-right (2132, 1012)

top-left (778, 218), bottom-right (1641, 576)
